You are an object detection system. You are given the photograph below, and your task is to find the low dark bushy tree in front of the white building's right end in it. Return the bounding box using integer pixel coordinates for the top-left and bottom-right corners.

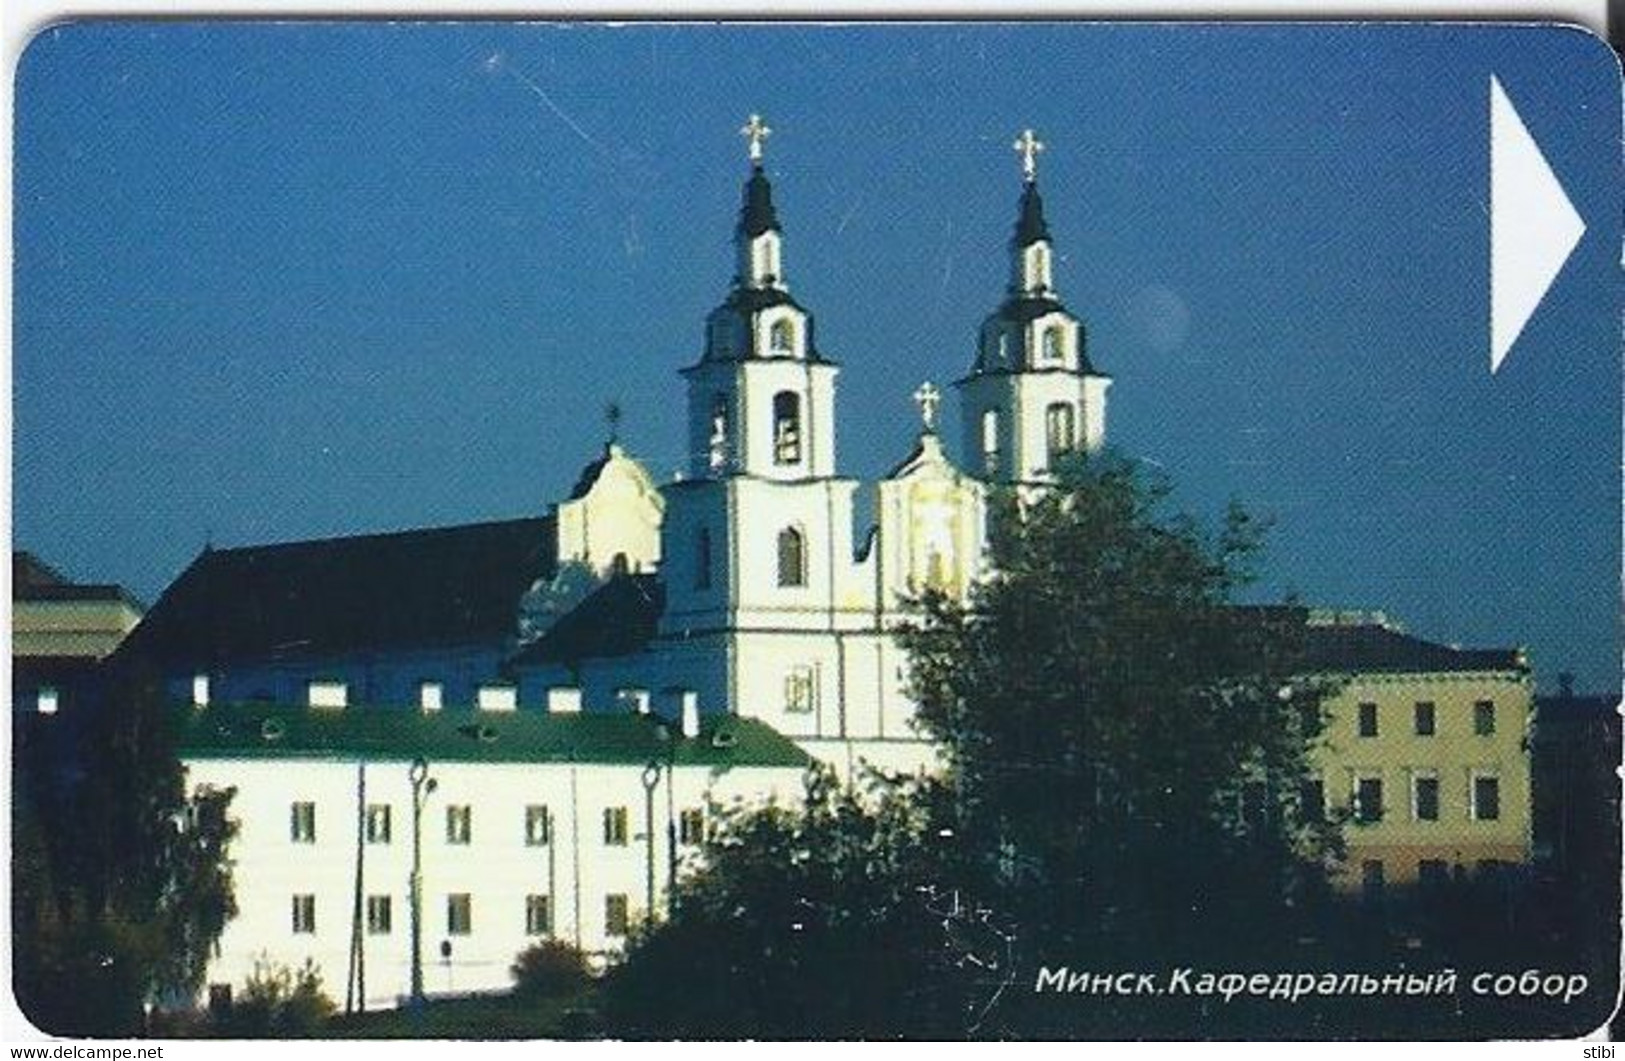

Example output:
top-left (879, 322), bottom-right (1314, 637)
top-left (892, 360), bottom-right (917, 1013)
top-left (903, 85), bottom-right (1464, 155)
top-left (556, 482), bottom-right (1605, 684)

top-left (605, 770), bottom-right (970, 1038)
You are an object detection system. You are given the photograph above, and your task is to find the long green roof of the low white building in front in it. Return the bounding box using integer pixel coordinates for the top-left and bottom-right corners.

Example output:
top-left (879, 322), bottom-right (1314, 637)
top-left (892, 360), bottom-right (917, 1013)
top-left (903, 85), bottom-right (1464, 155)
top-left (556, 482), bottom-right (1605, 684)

top-left (172, 704), bottom-right (813, 769)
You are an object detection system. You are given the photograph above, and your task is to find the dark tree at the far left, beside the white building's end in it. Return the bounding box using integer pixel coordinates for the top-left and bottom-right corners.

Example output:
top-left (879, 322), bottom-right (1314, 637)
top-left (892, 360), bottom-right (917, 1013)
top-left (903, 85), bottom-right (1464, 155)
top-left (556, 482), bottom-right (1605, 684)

top-left (13, 669), bottom-right (237, 1035)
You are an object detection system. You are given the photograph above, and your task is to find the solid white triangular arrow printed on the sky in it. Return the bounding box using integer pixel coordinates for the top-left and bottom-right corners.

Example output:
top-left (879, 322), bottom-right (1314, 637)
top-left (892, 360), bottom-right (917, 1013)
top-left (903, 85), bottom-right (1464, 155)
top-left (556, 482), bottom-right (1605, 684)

top-left (1490, 75), bottom-right (1586, 374)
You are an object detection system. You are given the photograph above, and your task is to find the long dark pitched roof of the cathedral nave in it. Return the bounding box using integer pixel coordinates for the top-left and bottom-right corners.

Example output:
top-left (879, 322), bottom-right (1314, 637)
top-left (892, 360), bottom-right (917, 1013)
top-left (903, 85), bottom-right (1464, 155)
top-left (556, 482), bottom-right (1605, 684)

top-left (119, 518), bottom-right (556, 665)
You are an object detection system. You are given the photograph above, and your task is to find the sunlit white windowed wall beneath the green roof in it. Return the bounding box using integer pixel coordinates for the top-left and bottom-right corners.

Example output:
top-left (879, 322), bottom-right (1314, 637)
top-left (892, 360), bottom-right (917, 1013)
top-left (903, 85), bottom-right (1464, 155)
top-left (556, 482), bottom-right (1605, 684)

top-left (187, 747), bottom-right (803, 1007)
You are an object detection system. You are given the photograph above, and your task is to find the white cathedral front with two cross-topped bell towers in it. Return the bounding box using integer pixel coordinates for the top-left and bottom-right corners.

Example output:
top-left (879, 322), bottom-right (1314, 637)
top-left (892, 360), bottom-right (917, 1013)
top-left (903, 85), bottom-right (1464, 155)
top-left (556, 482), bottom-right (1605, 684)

top-left (517, 117), bottom-right (1110, 772)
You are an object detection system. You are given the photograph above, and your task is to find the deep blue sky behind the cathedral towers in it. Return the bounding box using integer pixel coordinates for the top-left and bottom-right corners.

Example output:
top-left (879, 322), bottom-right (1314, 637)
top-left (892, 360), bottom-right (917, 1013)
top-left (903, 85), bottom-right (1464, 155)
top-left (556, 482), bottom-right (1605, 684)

top-left (13, 23), bottom-right (1622, 689)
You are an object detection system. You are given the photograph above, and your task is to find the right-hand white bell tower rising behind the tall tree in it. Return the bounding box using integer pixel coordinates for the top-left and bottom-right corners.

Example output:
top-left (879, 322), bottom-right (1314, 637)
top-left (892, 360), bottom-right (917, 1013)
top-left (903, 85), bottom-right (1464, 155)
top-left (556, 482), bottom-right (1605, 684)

top-left (956, 128), bottom-right (1112, 483)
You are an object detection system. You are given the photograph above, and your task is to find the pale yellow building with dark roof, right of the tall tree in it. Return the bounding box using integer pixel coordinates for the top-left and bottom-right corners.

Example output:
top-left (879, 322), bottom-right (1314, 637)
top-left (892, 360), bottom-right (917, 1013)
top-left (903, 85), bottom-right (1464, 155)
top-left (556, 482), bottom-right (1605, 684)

top-left (1307, 613), bottom-right (1534, 895)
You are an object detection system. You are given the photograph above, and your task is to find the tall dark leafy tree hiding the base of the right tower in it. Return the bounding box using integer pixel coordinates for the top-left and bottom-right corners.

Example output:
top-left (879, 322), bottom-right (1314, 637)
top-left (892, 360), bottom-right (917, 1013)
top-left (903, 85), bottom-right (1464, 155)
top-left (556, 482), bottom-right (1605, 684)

top-left (902, 453), bottom-right (1337, 964)
